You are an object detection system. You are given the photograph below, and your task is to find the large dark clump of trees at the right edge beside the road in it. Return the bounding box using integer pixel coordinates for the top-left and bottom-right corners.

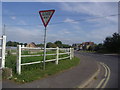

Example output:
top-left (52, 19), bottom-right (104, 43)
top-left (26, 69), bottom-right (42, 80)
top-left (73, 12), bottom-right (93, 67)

top-left (82, 33), bottom-right (120, 53)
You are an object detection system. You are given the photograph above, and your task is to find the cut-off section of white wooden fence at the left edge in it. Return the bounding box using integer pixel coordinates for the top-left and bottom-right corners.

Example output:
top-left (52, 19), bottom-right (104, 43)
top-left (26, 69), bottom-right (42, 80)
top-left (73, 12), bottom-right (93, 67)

top-left (0, 35), bottom-right (6, 68)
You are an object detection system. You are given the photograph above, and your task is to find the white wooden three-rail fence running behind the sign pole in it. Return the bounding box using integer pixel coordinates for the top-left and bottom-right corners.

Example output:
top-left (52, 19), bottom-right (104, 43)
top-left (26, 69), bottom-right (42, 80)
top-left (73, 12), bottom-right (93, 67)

top-left (17, 45), bottom-right (74, 74)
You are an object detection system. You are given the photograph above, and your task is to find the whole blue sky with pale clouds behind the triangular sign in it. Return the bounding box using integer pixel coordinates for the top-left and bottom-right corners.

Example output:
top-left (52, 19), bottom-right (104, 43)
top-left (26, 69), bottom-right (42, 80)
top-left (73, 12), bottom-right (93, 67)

top-left (2, 2), bottom-right (118, 44)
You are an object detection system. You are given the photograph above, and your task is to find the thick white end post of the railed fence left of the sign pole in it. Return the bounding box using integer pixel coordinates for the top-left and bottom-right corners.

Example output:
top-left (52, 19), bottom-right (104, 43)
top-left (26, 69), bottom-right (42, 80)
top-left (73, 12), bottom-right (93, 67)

top-left (17, 45), bottom-right (21, 74)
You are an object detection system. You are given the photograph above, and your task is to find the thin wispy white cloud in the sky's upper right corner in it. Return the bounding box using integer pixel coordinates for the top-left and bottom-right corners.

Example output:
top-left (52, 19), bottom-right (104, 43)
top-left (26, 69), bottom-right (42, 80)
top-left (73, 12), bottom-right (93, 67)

top-left (60, 2), bottom-right (118, 23)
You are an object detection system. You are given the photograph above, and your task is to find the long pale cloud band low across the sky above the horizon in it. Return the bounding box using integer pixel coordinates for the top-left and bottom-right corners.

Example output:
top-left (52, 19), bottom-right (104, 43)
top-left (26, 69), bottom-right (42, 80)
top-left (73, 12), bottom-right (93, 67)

top-left (6, 24), bottom-right (118, 44)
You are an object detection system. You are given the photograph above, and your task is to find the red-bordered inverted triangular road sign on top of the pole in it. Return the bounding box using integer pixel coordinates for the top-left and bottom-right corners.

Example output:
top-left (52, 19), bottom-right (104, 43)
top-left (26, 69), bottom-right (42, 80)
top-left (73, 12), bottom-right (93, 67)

top-left (39, 10), bottom-right (55, 27)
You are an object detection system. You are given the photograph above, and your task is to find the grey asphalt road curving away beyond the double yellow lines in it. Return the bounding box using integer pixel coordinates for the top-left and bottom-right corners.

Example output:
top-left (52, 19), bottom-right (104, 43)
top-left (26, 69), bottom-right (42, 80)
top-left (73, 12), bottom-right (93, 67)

top-left (75, 51), bottom-right (120, 88)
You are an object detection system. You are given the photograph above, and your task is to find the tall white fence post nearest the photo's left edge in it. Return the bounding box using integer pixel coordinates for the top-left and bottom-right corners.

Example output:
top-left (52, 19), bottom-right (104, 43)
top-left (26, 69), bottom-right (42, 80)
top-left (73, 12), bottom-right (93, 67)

top-left (1, 35), bottom-right (6, 68)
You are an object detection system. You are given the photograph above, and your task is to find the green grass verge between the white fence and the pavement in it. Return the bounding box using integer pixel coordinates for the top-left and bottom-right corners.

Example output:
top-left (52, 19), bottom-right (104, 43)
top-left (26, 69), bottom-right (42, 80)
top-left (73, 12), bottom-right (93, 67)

top-left (13, 58), bottom-right (79, 83)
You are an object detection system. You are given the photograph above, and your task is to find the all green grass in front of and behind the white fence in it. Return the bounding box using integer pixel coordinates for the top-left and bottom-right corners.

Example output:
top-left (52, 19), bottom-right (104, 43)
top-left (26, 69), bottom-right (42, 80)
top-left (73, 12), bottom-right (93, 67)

top-left (6, 52), bottom-right (80, 83)
